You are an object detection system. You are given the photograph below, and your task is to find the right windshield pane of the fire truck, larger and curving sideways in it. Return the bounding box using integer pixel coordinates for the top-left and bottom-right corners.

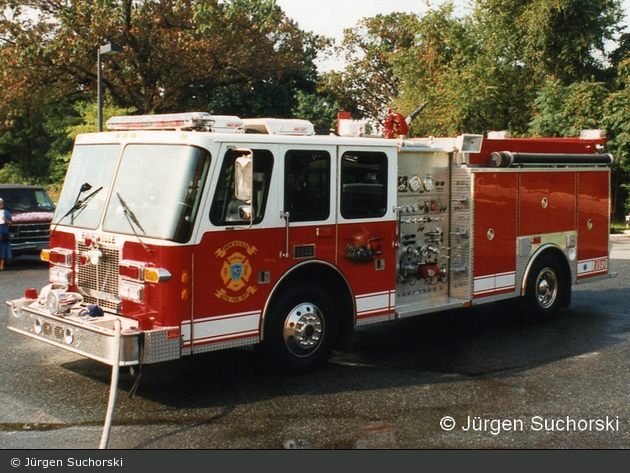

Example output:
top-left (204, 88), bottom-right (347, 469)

top-left (103, 144), bottom-right (210, 243)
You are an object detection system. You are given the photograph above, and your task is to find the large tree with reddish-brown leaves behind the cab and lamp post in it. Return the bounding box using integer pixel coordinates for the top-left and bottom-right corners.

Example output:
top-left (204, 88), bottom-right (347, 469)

top-left (0, 0), bottom-right (328, 183)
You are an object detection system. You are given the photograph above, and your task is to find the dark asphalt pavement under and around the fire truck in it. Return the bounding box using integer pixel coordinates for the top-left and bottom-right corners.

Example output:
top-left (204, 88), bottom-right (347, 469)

top-left (0, 235), bottom-right (630, 450)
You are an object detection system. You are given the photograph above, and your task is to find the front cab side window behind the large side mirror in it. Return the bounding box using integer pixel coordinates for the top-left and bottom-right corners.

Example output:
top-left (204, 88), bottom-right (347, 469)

top-left (210, 149), bottom-right (273, 226)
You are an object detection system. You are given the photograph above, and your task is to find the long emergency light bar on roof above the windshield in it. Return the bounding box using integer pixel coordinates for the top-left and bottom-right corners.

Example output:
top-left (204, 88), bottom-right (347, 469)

top-left (106, 112), bottom-right (220, 131)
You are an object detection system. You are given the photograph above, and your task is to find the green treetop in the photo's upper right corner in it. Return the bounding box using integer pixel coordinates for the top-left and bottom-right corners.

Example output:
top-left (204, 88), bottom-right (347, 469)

top-left (474, 0), bottom-right (623, 85)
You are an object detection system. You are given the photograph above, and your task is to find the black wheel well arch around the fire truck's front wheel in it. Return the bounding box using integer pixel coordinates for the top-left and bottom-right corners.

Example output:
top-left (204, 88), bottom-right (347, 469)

top-left (260, 261), bottom-right (355, 349)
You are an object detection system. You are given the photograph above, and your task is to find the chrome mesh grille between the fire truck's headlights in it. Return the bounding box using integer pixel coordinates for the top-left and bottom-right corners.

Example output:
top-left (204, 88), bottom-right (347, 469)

top-left (77, 243), bottom-right (120, 313)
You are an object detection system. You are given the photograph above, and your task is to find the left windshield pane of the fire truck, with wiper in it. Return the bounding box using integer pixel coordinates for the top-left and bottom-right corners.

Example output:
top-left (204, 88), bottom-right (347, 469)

top-left (53, 145), bottom-right (120, 229)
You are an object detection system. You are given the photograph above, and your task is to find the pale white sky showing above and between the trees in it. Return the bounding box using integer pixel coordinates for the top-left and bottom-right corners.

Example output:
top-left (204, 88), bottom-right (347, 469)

top-left (276, 0), bottom-right (630, 70)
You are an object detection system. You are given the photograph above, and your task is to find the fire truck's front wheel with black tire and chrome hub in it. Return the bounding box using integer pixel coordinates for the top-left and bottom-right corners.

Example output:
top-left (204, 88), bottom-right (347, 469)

top-left (261, 283), bottom-right (336, 373)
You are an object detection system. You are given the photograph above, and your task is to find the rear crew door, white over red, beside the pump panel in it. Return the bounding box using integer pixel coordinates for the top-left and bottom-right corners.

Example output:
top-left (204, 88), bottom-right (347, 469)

top-left (337, 146), bottom-right (397, 323)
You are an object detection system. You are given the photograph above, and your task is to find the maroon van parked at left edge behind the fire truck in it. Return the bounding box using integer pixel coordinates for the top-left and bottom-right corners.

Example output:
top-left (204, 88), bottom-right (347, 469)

top-left (0, 184), bottom-right (55, 256)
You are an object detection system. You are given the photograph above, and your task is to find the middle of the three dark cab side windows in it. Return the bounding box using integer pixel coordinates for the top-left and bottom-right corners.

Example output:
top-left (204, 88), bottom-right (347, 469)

top-left (284, 150), bottom-right (330, 222)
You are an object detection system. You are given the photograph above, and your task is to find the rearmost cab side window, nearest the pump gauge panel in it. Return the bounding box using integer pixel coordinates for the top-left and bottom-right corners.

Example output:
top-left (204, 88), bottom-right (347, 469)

top-left (340, 152), bottom-right (387, 219)
